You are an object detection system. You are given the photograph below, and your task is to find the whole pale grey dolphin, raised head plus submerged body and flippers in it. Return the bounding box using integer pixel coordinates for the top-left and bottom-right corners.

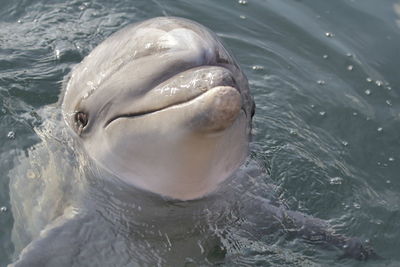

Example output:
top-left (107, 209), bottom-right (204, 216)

top-left (10, 17), bottom-right (374, 266)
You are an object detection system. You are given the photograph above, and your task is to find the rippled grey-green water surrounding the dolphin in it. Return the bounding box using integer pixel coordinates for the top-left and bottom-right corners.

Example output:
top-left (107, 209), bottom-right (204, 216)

top-left (0, 0), bottom-right (400, 266)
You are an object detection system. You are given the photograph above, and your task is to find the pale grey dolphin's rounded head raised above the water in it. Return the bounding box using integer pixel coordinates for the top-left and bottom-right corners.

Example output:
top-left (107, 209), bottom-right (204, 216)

top-left (62, 17), bottom-right (254, 200)
